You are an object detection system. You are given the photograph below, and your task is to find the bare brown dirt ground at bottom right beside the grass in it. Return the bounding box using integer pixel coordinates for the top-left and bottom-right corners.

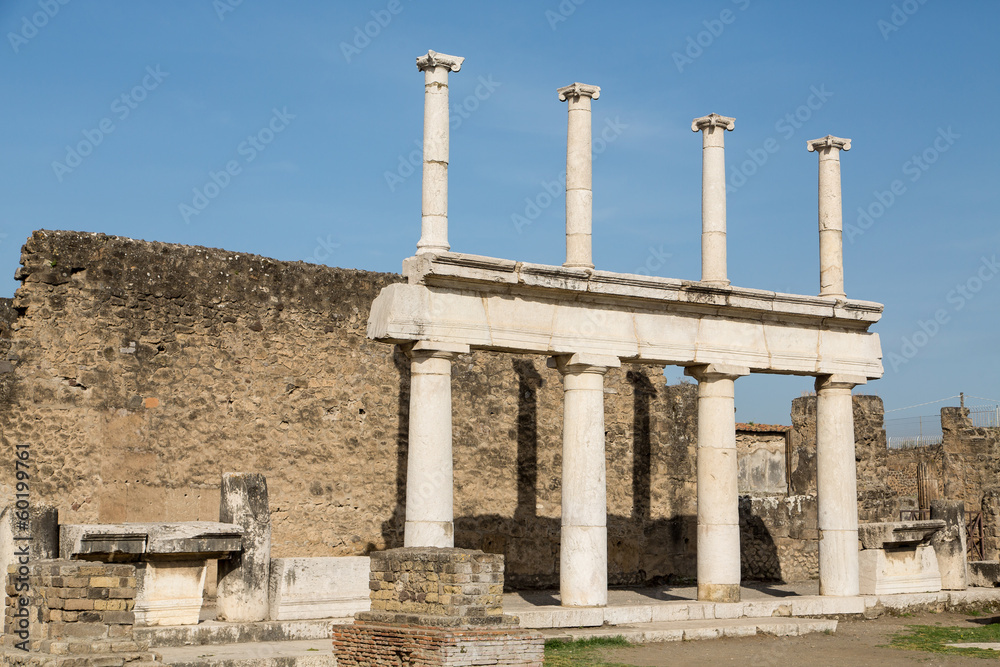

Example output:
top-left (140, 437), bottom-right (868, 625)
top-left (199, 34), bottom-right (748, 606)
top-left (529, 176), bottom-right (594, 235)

top-left (602, 612), bottom-right (1000, 667)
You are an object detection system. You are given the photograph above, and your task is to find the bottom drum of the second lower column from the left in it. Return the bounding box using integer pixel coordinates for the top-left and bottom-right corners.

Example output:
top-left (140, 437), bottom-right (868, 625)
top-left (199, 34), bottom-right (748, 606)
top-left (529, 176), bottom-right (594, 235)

top-left (559, 526), bottom-right (608, 607)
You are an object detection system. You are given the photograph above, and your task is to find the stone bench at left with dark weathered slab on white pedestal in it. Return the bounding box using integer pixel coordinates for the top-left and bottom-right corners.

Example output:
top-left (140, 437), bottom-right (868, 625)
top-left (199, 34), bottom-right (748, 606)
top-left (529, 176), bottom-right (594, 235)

top-left (59, 521), bottom-right (243, 625)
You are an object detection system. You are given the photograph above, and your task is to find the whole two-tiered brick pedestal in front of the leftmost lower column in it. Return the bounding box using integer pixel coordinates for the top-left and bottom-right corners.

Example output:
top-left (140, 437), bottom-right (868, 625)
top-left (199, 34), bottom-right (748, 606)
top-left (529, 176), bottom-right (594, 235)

top-left (333, 547), bottom-right (544, 667)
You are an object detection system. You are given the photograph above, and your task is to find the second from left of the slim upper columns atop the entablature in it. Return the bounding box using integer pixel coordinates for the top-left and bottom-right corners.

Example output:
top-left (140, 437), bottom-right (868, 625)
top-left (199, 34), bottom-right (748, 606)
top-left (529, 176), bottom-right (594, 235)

top-left (557, 83), bottom-right (601, 269)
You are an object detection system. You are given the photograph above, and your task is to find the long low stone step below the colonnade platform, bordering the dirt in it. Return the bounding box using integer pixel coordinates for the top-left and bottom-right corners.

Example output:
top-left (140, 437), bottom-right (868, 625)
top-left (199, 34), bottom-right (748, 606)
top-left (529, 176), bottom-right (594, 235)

top-left (540, 618), bottom-right (837, 644)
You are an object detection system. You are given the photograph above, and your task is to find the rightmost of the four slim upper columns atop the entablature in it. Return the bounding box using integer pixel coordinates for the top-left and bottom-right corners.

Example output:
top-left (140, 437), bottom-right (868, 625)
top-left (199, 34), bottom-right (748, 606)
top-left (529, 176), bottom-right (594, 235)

top-left (806, 134), bottom-right (851, 299)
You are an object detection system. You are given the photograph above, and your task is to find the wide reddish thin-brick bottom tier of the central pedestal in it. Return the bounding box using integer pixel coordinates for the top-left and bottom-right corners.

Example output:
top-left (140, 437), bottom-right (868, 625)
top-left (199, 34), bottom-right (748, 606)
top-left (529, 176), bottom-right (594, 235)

top-left (333, 621), bottom-right (545, 667)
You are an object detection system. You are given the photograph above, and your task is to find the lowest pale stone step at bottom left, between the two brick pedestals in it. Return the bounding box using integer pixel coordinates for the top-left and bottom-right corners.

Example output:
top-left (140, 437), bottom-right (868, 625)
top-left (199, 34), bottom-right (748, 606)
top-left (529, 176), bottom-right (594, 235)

top-left (156, 639), bottom-right (337, 667)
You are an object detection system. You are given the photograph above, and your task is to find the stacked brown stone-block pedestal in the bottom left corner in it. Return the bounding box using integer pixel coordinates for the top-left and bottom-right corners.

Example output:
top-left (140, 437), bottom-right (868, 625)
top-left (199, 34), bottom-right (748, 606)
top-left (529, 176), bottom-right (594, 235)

top-left (0, 560), bottom-right (162, 667)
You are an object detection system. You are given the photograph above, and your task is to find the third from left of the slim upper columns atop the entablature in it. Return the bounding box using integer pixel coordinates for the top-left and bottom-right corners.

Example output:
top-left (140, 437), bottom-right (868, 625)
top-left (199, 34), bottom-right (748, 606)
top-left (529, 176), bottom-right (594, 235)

top-left (691, 113), bottom-right (736, 285)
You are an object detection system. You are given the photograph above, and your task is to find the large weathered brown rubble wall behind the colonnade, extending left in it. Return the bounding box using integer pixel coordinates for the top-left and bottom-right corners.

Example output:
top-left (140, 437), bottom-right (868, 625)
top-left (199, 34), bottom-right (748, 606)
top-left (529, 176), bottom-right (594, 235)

top-left (0, 231), bottom-right (696, 586)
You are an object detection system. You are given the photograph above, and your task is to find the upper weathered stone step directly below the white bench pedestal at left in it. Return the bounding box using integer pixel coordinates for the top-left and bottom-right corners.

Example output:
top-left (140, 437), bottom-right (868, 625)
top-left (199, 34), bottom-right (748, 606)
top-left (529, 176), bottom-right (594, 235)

top-left (135, 617), bottom-right (354, 649)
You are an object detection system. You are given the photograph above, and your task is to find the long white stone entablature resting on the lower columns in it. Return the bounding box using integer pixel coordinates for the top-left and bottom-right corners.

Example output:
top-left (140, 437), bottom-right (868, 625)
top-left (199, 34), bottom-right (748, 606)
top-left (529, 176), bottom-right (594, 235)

top-left (368, 253), bottom-right (882, 379)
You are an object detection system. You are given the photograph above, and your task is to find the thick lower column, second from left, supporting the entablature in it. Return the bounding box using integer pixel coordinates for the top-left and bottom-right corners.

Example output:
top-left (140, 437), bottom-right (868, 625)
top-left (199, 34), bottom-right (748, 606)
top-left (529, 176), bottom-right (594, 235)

top-left (549, 354), bottom-right (621, 607)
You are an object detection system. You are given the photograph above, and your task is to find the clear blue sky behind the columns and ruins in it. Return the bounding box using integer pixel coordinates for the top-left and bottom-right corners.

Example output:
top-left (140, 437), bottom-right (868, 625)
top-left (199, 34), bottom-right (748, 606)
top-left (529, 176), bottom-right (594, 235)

top-left (0, 0), bottom-right (1000, 423)
